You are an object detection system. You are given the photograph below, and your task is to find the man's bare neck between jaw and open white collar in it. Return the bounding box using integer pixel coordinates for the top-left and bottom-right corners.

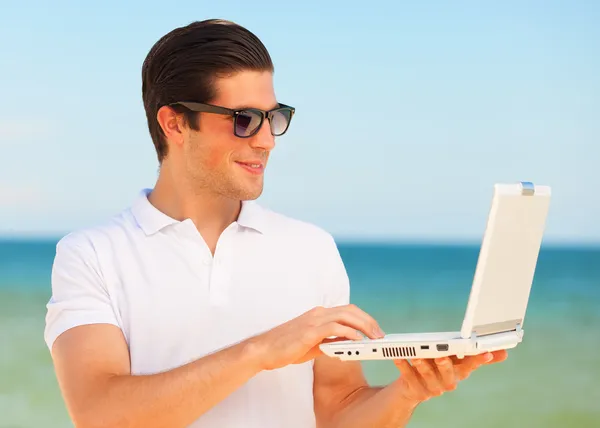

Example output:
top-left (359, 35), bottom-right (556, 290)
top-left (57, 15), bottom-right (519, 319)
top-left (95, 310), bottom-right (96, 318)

top-left (148, 165), bottom-right (241, 253)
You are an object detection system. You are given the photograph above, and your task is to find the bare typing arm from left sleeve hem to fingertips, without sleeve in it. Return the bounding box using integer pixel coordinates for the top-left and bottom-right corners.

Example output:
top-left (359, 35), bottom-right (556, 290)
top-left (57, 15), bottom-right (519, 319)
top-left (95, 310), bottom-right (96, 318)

top-left (52, 305), bottom-right (386, 428)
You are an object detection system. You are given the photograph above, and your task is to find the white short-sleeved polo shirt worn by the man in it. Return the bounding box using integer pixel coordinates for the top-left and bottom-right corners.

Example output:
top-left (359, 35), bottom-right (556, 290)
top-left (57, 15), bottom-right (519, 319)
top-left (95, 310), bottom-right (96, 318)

top-left (44, 189), bottom-right (349, 428)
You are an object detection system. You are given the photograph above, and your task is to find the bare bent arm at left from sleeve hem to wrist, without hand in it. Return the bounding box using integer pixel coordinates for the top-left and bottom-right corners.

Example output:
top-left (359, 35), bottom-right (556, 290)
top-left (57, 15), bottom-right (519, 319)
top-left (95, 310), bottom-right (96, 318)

top-left (52, 324), bottom-right (260, 428)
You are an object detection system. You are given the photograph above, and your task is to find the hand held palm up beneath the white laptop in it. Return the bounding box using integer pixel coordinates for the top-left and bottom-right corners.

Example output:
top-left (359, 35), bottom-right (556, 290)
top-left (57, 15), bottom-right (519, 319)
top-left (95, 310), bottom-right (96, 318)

top-left (394, 350), bottom-right (508, 404)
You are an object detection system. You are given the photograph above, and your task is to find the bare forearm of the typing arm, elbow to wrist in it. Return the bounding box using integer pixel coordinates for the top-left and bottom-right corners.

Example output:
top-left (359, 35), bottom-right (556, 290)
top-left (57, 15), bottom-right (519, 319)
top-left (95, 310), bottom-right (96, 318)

top-left (76, 342), bottom-right (260, 428)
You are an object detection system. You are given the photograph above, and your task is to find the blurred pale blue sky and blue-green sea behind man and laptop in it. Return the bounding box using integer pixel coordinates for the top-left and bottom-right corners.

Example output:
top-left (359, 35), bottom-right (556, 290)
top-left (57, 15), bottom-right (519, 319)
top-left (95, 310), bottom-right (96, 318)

top-left (0, 0), bottom-right (600, 428)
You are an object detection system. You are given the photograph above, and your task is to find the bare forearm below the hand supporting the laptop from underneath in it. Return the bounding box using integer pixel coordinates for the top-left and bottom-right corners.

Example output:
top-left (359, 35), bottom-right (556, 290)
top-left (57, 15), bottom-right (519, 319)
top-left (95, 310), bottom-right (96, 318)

top-left (332, 382), bottom-right (417, 428)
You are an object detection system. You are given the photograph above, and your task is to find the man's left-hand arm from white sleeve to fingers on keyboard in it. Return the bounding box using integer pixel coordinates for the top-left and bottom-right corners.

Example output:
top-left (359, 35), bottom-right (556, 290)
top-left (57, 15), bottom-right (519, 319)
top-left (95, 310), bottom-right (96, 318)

top-left (45, 238), bottom-right (378, 428)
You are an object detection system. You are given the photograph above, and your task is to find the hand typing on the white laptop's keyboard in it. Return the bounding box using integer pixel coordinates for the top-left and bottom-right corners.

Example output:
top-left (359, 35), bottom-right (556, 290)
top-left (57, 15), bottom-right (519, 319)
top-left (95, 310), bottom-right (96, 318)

top-left (251, 305), bottom-right (384, 370)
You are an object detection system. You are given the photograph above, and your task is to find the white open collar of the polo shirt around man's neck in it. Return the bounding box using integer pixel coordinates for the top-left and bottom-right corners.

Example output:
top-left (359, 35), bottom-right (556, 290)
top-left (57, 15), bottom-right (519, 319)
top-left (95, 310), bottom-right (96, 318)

top-left (131, 189), bottom-right (267, 235)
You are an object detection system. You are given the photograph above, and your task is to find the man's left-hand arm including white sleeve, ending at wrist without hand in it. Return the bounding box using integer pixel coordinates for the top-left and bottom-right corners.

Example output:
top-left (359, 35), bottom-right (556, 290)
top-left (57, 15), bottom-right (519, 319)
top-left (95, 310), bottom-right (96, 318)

top-left (45, 235), bottom-right (270, 428)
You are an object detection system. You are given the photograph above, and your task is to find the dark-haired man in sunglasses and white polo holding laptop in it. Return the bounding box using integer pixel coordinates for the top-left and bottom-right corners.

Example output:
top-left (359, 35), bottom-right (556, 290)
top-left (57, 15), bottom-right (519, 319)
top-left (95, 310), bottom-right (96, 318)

top-left (45, 20), bottom-right (506, 428)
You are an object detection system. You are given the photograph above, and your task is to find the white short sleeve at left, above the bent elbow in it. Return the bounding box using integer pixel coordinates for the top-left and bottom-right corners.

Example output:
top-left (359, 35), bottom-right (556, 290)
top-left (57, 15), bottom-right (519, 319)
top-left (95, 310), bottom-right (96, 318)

top-left (44, 235), bottom-right (119, 350)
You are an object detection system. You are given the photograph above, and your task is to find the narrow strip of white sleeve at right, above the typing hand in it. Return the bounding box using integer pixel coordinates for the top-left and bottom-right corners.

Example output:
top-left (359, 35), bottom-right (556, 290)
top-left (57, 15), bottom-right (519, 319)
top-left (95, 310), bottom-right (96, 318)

top-left (324, 236), bottom-right (350, 308)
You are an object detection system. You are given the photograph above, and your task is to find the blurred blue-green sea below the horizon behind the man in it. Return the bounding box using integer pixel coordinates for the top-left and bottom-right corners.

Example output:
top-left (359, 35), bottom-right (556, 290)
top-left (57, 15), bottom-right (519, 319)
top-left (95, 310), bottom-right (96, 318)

top-left (0, 239), bottom-right (600, 428)
